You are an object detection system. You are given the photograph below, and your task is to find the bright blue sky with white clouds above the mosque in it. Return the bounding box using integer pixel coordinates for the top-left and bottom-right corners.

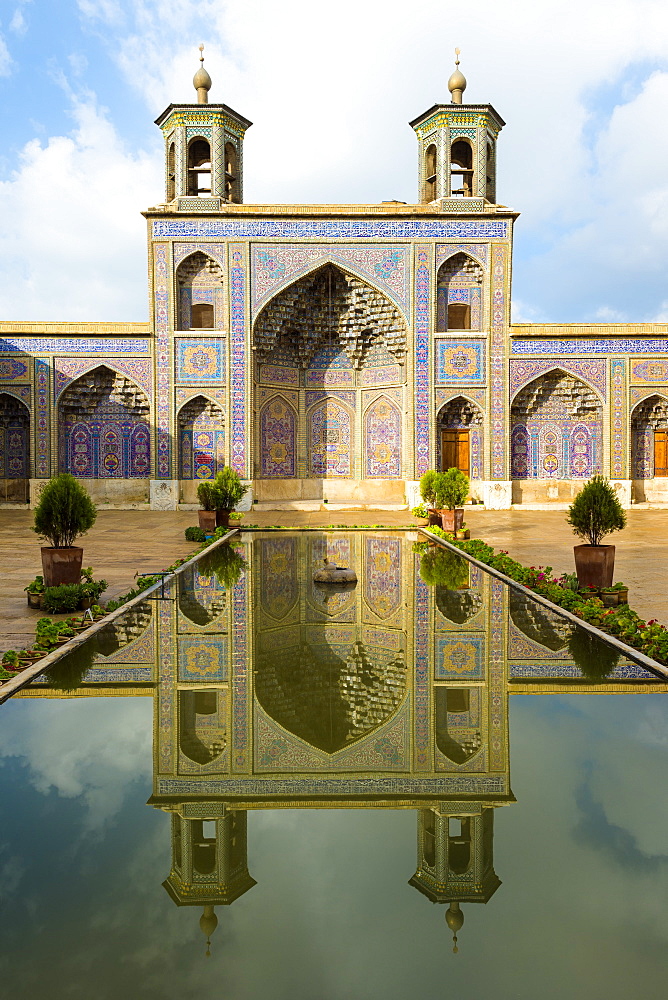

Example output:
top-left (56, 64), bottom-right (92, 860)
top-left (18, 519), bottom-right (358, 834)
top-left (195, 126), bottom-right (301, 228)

top-left (0, 0), bottom-right (668, 323)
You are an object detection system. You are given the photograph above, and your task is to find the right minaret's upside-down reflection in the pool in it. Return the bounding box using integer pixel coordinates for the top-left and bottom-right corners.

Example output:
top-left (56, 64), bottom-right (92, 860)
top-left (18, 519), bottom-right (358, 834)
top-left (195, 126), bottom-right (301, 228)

top-left (409, 802), bottom-right (501, 952)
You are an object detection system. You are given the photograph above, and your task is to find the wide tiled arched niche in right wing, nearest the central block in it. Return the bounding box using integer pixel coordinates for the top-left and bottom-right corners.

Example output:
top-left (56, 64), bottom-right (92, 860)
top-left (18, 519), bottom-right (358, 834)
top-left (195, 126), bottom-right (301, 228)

top-left (510, 368), bottom-right (603, 480)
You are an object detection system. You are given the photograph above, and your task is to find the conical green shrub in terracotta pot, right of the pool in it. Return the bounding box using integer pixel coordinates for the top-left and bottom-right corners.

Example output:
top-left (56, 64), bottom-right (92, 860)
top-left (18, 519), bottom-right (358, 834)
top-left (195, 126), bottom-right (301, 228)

top-left (566, 476), bottom-right (626, 589)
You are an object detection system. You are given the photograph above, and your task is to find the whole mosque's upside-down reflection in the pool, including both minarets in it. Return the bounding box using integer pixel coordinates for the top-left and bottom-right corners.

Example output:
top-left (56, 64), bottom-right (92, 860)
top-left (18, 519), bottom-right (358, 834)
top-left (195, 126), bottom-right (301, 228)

top-left (22, 532), bottom-right (664, 947)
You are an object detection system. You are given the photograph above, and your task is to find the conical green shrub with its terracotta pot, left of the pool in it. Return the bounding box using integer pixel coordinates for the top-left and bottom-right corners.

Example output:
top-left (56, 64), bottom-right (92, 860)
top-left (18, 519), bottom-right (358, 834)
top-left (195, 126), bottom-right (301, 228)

top-left (33, 472), bottom-right (97, 587)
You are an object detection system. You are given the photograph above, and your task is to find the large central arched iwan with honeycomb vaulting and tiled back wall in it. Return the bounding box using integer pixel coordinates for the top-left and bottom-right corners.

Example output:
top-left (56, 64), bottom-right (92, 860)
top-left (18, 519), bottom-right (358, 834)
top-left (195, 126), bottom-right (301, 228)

top-left (253, 264), bottom-right (406, 497)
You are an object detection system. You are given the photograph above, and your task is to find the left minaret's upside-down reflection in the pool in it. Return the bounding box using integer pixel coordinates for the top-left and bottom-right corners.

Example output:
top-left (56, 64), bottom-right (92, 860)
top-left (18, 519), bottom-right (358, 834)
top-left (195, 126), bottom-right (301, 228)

top-left (162, 802), bottom-right (256, 955)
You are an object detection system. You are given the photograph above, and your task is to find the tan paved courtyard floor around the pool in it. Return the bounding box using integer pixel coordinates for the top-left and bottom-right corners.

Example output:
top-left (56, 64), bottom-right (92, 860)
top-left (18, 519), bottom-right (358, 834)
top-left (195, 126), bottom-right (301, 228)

top-left (0, 507), bottom-right (668, 651)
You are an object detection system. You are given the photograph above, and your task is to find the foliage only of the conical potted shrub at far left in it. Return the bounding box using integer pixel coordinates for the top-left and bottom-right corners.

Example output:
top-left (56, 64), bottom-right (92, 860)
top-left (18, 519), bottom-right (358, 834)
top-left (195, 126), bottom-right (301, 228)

top-left (33, 472), bottom-right (97, 549)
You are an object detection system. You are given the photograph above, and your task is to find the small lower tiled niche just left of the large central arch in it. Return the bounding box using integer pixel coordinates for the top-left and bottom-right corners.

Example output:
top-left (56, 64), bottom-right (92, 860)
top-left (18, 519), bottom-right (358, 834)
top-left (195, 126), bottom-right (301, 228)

top-left (178, 395), bottom-right (225, 479)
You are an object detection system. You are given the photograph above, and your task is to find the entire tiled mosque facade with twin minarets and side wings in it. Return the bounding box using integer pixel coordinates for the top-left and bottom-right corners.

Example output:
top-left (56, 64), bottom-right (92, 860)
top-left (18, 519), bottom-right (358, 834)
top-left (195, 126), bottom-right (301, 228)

top-left (0, 53), bottom-right (668, 509)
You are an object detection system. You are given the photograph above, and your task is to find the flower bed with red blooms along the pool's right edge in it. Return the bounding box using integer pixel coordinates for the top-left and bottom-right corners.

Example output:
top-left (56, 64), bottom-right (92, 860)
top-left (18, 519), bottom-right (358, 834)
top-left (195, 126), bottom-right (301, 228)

top-left (429, 527), bottom-right (668, 665)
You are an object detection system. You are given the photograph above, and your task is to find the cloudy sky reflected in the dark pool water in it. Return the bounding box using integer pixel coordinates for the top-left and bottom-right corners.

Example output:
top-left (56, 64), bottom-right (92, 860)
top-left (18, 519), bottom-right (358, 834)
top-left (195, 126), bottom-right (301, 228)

top-left (0, 695), bottom-right (668, 1000)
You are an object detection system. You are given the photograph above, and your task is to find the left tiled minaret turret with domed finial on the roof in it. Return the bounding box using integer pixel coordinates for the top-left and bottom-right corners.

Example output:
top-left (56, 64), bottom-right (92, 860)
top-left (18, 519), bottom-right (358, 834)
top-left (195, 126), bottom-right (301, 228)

top-left (155, 45), bottom-right (252, 212)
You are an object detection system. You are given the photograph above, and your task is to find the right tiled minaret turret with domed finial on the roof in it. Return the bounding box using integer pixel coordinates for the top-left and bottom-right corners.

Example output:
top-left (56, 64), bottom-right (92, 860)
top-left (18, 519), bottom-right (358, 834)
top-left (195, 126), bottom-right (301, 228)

top-left (410, 49), bottom-right (505, 212)
